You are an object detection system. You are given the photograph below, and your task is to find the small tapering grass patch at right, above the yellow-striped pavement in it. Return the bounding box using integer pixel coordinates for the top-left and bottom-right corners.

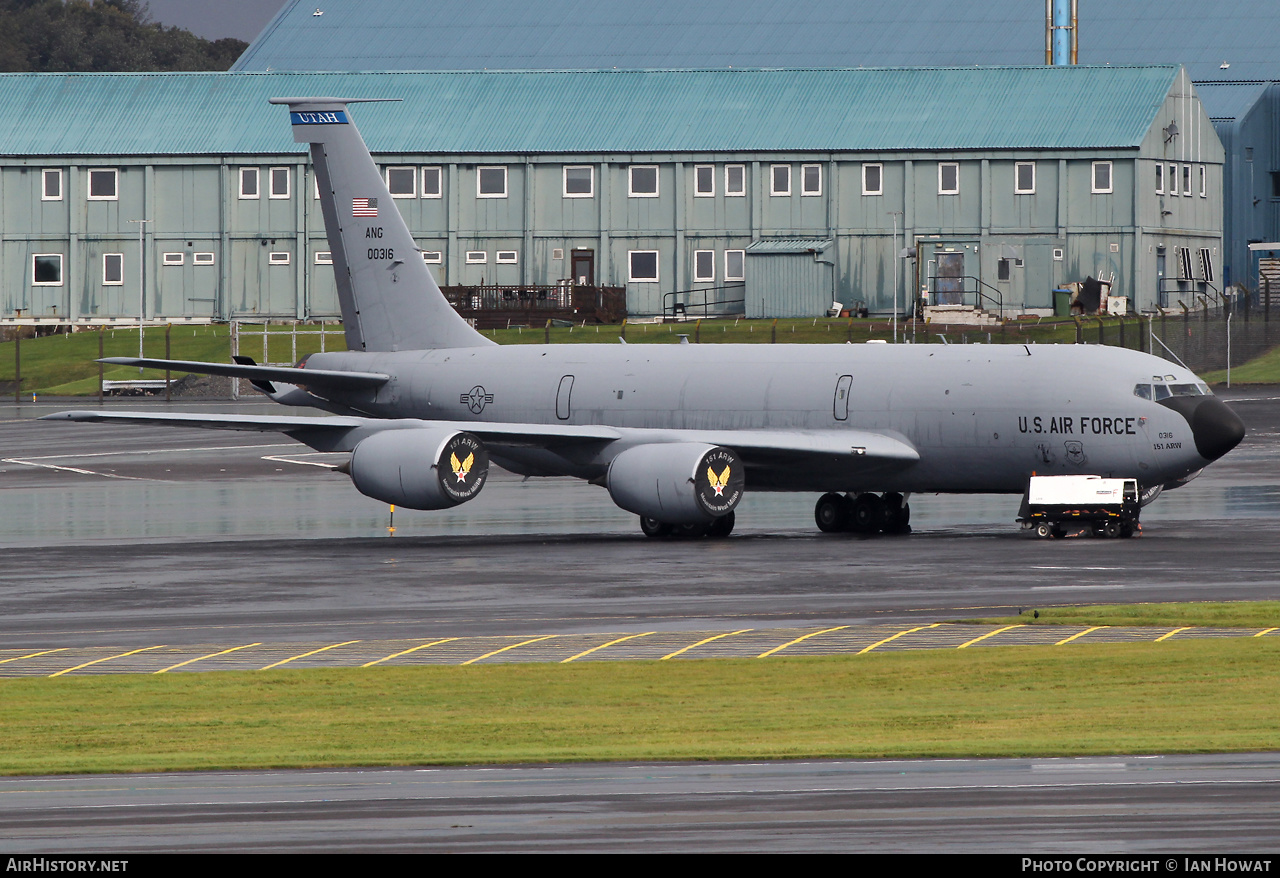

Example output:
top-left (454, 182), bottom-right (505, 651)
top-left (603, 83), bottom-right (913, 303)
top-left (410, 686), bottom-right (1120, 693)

top-left (960, 600), bottom-right (1280, 628)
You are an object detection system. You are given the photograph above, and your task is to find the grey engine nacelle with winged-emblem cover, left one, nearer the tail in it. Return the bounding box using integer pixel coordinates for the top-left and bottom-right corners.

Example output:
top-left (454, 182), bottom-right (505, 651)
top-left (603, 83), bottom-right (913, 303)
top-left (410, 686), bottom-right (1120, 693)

top-left (349, 427), bottom-right (489, 509)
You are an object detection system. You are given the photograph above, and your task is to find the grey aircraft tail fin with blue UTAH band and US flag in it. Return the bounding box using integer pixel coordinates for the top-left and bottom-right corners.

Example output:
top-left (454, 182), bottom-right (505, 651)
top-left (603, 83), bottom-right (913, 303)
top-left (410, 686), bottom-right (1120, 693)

top-left (271, 97), bottom-right (492, 351)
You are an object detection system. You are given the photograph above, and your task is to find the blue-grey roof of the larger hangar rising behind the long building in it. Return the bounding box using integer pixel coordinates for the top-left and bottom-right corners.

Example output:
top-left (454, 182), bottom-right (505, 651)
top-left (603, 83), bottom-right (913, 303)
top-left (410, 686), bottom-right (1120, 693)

top-left (234, 0), bottom-right (1280, 81)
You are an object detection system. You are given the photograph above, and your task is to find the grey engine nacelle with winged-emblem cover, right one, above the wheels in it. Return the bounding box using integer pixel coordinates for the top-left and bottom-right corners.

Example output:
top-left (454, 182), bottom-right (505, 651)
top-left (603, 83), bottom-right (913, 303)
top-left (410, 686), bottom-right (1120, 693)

top-left (605, 443), bottom-right (744, 525)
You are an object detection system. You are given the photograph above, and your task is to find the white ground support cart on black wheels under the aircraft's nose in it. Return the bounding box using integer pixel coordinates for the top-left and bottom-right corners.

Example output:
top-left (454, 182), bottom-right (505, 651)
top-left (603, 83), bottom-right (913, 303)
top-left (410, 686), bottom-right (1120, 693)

top-left (1018, 476), bottom-right (1140, 536)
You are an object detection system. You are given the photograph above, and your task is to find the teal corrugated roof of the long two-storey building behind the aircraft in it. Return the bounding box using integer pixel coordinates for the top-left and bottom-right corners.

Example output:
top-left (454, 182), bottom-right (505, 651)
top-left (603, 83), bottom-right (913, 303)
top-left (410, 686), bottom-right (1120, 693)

top-left (0, 67), bottom-right (1178, 155)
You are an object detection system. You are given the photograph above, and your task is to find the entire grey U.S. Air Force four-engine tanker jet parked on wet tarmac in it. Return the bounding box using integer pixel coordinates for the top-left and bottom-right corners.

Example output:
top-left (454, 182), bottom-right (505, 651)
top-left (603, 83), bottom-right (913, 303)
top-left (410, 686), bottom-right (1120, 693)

top-left (49, 97), bottom-right (1244, 536)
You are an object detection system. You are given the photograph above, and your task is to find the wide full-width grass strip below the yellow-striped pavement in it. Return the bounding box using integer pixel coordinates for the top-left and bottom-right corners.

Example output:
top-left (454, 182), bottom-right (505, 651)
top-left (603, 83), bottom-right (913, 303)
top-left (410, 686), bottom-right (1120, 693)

top-left (0, 637), bottom-right (1280, 774)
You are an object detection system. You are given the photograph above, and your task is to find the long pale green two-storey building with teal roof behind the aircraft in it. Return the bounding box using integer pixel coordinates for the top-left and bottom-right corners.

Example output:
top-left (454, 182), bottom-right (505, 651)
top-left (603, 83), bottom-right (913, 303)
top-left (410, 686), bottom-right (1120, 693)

top-left (0, 67), bottom-right (1222, 320)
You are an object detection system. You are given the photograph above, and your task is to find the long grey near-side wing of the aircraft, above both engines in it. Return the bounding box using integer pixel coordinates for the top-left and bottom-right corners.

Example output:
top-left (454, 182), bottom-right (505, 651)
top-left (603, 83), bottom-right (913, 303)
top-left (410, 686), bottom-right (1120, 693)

top-left (41, 417), bottom-right (920, 467)
